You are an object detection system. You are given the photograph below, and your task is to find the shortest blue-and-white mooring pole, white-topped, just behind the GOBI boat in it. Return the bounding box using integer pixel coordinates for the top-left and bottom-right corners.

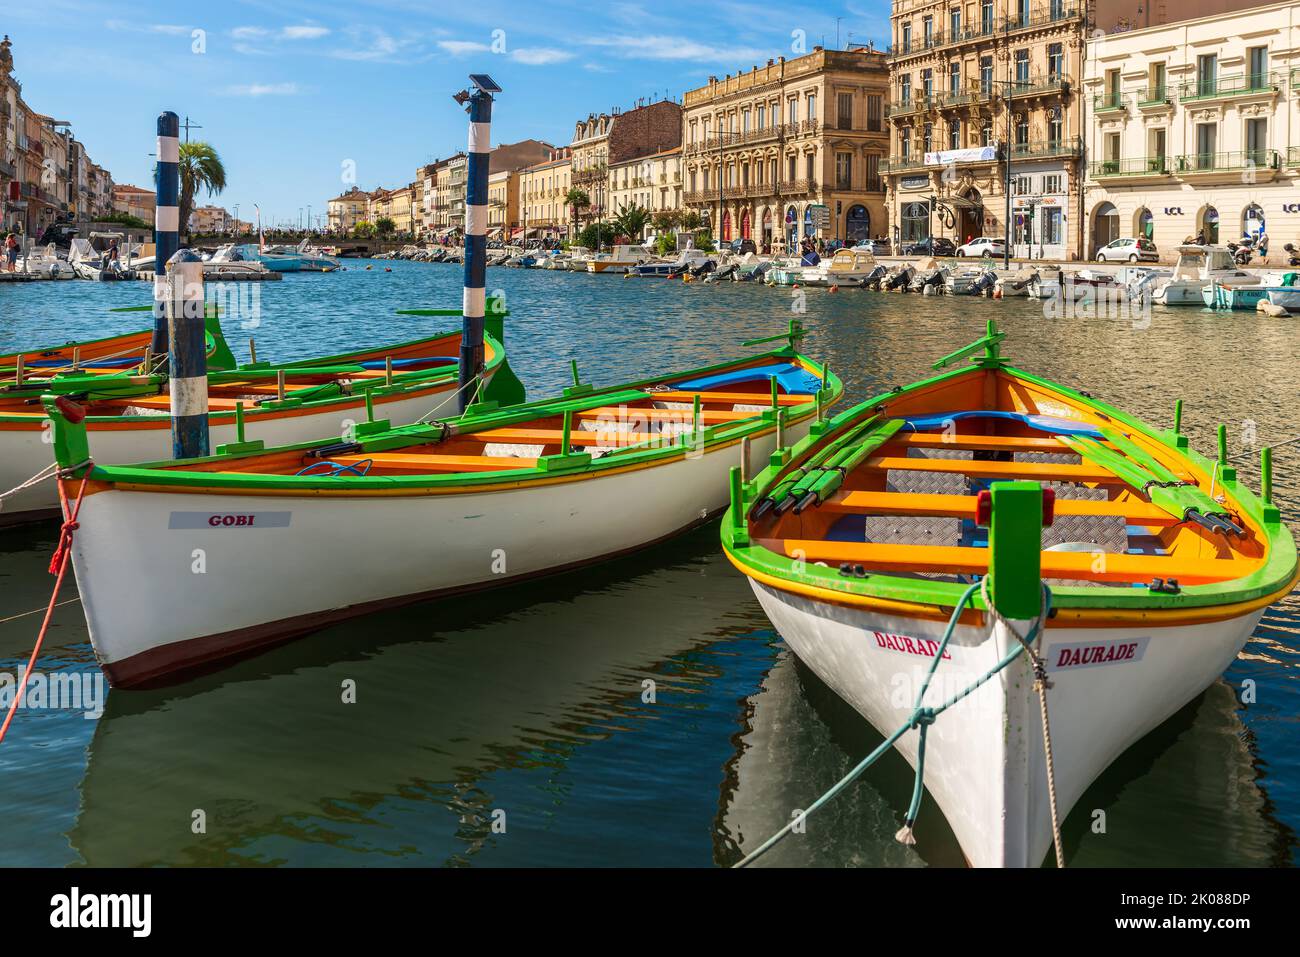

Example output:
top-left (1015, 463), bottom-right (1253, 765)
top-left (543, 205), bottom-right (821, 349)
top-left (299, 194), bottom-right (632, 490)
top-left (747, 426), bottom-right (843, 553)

top-left (164, 250), bottom-right (208, 459)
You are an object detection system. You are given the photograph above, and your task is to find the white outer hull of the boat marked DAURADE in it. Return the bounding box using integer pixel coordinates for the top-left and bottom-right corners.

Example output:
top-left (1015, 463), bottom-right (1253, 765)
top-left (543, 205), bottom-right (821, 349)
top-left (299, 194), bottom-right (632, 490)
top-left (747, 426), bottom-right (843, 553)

top-left (751, 580), bottom-right (1262, 867)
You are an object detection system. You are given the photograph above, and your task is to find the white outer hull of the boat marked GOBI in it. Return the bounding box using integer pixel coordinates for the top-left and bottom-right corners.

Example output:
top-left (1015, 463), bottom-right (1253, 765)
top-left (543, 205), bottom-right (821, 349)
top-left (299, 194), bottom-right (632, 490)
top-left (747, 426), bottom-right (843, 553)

top-left (73, 417), bottom-right (811, 687)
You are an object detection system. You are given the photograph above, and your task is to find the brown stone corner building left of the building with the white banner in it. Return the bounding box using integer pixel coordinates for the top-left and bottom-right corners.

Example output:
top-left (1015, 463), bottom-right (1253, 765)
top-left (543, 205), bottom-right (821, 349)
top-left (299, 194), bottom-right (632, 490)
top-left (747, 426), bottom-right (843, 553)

top-left (683, 47), bottom-right (889, 248)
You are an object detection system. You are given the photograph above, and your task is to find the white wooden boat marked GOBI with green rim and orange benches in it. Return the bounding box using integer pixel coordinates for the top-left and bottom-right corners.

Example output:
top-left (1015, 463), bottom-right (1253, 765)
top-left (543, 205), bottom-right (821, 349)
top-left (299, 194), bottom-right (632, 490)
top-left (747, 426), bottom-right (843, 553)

top-left (47, 324), bottom-right (842, 685)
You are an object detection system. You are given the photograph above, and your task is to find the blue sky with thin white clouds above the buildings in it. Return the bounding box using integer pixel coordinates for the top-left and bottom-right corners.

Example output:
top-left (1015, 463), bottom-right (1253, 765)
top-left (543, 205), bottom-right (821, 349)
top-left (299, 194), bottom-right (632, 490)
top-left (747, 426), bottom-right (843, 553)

top-left (0, 0), bottom-right (891, 225)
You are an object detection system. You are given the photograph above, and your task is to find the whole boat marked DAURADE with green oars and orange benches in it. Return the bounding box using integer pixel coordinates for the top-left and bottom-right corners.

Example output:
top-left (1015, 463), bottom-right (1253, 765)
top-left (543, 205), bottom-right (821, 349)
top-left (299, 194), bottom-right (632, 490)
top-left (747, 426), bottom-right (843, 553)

top-left (723, 322), bottom-right (1297, 867)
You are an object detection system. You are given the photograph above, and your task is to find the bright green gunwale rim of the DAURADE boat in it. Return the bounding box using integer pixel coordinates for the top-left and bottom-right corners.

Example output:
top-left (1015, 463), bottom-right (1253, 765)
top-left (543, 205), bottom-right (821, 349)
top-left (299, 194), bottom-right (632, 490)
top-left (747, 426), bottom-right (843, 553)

top-left (722, 359), bottom-right (1300, 613)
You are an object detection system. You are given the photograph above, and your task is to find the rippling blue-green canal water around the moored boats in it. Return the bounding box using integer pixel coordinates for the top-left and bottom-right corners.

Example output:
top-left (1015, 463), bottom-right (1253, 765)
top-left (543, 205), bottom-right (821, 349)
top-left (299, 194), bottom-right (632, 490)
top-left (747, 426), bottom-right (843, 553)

top-left (0, 261), bottom-right (1300, 867)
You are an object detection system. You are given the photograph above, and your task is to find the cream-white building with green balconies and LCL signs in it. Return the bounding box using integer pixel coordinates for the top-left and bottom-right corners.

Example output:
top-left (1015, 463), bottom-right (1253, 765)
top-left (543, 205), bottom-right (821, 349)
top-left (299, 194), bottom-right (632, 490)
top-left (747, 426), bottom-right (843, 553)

top-left (1084, 3), bottom-right (1300, 259)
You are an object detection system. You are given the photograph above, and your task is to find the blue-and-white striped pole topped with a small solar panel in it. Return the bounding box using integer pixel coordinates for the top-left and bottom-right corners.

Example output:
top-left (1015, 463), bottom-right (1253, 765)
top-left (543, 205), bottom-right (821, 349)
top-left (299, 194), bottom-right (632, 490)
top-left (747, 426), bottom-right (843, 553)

top-left (459, 87), bottom-right (491, 412)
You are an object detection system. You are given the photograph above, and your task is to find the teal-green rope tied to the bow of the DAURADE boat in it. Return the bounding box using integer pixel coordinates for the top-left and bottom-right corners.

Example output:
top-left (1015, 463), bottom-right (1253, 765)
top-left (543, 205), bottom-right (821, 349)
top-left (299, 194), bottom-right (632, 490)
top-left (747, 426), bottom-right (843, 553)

top-left (732, 581), bottom-right (1052, 867)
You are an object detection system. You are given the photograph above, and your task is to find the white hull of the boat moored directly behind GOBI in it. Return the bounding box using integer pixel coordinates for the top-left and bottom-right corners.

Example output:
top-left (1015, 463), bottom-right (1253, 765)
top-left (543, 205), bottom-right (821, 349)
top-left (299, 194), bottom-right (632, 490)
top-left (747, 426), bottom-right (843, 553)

top-left (0, 369), bottom-right (483, 527)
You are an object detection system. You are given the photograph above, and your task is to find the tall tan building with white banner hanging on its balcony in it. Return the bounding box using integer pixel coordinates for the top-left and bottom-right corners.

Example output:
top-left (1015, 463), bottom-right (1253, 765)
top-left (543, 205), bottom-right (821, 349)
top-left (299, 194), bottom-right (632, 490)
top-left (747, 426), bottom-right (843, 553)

top-left (885, 0), bottom-right (1087, 259)
